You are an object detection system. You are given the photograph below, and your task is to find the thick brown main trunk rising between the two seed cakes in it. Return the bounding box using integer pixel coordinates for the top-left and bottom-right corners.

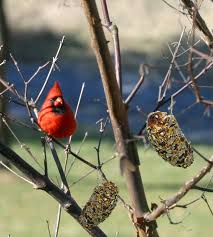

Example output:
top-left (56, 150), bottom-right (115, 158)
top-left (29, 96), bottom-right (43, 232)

top-left (82, 0), bottom-right (158, 237)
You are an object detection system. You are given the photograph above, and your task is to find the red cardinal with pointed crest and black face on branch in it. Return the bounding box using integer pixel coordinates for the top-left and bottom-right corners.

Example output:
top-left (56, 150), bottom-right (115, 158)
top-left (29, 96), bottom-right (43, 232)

top-left (38, 82), bottom-right (77, 138)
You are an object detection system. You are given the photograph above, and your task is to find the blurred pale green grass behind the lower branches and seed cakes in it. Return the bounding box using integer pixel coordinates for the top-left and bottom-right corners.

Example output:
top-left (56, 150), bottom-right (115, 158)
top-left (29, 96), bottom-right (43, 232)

top-left (0, 134), bottom-right (213, 237)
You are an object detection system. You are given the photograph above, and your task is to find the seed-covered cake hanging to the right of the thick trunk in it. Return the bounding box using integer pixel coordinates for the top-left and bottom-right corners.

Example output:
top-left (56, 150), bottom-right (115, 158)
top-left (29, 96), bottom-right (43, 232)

top-left (146, 111), bottom-right (194, 168)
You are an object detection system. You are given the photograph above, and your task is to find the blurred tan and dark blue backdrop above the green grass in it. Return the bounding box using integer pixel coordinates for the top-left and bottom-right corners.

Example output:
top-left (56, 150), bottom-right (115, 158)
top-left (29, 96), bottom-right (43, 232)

top-left (3, 0), bottom-right (213, 142)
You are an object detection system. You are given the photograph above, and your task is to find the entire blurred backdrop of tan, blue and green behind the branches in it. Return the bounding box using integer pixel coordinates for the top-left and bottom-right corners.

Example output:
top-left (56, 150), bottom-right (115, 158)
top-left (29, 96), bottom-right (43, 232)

top-left (0, 0), bottom-right (213, 237)
